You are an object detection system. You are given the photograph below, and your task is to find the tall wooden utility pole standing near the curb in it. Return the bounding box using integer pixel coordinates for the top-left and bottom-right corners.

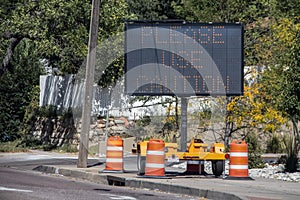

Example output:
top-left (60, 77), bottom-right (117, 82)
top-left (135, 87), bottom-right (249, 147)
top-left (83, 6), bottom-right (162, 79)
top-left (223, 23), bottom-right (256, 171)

top-left (77, 0), bottom-right (100, 168)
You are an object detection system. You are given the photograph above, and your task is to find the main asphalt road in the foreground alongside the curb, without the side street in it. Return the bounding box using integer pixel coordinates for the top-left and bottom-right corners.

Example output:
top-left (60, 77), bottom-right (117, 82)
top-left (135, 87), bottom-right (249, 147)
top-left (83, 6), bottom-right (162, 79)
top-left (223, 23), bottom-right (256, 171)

top-left (0, 167), bottom-right (199, 200)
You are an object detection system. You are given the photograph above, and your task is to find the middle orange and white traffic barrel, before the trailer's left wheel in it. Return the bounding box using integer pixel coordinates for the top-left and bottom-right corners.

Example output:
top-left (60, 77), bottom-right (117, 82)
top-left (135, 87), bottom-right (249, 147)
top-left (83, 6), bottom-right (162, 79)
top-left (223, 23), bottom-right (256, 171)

top-left (145, 139), bottom-right (165, 177)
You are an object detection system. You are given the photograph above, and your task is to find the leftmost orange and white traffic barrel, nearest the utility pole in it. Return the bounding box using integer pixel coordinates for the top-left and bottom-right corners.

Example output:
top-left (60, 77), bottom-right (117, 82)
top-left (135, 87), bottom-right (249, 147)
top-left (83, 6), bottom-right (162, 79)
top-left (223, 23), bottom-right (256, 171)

top-left (104, 136), bottom-right (123, 172)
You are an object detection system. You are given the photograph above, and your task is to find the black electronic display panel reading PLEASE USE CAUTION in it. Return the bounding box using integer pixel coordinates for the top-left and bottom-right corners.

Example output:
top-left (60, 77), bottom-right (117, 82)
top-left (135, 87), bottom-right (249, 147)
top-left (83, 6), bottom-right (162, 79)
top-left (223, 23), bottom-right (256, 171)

top-left (125, 21), bottom-right (244, 96)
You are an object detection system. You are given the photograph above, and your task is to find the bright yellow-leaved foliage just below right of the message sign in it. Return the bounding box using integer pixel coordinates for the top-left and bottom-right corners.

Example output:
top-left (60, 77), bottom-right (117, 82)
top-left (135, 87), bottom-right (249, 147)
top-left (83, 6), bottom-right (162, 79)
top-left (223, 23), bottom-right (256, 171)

top-left (227, 84), bottom-right (286, 136)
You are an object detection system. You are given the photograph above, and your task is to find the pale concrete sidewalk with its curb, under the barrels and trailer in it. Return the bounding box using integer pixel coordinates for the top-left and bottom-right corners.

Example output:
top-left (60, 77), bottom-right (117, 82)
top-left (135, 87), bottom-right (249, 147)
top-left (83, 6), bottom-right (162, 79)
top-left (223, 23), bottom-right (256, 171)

top-left (35, 163), bottom-right (300, 200)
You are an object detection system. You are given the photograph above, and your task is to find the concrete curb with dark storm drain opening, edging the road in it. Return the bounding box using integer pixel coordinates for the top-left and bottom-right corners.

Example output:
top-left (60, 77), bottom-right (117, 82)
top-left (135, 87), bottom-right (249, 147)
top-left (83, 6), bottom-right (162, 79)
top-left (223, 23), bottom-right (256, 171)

top-left (33, 165), bottom-right (244, 200)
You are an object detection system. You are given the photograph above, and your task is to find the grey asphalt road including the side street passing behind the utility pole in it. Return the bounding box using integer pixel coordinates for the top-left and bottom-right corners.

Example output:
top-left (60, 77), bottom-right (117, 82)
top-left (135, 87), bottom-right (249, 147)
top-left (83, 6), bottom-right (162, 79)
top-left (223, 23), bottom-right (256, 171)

top-left (0, 154), bottom-right (194, 200)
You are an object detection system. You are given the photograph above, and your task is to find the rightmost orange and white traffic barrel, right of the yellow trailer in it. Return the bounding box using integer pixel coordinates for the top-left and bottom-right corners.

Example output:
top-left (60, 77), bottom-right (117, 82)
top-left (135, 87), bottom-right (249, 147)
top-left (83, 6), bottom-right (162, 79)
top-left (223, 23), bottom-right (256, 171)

top-left (229, 140), bottom-right (252, 179)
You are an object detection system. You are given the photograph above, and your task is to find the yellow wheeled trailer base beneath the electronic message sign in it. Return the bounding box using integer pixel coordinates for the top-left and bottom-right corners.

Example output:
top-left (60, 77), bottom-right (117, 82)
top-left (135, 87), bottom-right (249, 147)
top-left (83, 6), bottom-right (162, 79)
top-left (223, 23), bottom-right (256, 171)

top-left (137, 138), bottom-right (229, 176)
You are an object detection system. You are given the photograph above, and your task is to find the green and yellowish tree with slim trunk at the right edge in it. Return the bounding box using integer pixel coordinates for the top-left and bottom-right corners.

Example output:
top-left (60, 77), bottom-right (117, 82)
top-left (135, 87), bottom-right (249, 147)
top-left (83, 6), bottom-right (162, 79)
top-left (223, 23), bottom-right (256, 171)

top-left (262, 18), bottom-right (300, 172)
